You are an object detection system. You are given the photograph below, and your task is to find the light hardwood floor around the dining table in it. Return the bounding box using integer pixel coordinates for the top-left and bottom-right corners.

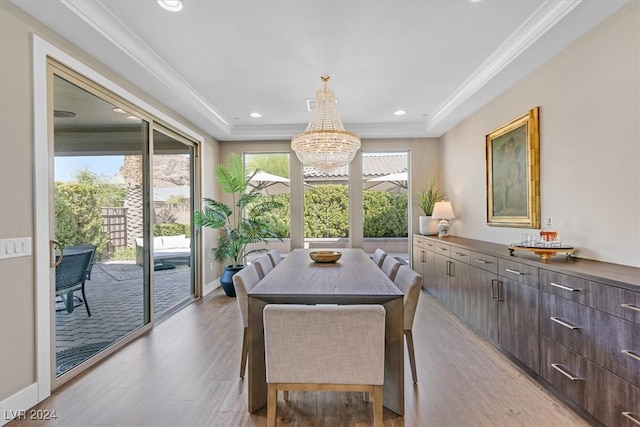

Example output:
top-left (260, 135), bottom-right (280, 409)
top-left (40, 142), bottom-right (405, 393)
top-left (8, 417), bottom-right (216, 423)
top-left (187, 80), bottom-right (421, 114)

top-left (8, 290), bottom-right (588, 427)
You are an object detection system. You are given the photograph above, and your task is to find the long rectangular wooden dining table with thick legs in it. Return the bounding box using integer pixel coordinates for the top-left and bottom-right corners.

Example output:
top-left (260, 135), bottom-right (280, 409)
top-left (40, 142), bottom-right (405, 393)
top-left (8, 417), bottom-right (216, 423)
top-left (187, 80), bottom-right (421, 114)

top-left (247, 248), bottom-right (404, 415)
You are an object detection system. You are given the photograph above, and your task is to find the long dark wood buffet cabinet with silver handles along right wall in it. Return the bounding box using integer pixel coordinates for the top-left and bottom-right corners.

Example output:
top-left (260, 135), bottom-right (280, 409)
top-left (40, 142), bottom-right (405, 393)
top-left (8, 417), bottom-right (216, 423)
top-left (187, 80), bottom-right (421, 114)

top-left (412, 234), bottom-right (640, 427)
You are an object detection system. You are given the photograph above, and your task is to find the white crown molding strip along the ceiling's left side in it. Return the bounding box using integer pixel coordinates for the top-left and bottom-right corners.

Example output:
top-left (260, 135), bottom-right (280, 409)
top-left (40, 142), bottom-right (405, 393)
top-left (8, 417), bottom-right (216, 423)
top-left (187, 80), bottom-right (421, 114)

top-left (60, 0), bottom-right (231, 135)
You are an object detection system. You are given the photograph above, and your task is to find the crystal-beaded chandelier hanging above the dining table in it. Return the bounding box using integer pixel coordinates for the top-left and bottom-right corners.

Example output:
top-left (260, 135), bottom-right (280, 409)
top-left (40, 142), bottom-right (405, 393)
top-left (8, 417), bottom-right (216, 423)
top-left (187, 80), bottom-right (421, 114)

top-left (291, 76), bottom-right (360, 173)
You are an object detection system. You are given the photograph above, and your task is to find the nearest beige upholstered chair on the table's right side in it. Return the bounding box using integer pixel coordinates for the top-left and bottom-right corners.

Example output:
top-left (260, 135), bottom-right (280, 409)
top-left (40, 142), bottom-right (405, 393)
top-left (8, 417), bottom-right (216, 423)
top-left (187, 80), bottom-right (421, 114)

top-left (393, 265), bottom-right (422, 383)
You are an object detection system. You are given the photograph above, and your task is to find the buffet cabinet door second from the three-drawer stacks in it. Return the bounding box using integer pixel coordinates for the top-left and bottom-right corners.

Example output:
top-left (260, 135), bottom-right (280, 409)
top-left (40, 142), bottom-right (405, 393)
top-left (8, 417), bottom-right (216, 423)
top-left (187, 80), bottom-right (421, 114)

top-left (467, 267), bottom-right (498, 344)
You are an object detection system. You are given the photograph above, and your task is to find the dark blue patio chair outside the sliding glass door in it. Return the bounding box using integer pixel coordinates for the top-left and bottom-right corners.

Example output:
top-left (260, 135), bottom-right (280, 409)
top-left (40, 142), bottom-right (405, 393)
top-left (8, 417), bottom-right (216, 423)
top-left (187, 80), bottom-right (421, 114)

top-left (56, 250), bottom-right (94, 317)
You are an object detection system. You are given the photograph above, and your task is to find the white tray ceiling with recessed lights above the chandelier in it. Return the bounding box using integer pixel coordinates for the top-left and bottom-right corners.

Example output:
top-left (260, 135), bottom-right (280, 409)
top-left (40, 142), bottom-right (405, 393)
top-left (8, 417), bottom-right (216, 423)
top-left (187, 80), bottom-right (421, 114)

top-left (12, 0), bottom-right (627, 141)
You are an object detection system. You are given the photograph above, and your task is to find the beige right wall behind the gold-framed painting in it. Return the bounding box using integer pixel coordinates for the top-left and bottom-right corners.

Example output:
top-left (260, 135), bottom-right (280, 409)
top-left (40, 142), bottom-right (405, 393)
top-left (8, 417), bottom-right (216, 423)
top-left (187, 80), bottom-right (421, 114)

top-left (441, 2), bottom-right (640, 267)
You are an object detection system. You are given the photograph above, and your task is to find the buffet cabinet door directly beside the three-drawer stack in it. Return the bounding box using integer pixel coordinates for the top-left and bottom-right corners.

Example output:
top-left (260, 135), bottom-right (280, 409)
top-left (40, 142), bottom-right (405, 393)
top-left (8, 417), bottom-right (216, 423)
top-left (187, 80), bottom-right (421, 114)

top-left (497, 278), bottom-right (540, 373)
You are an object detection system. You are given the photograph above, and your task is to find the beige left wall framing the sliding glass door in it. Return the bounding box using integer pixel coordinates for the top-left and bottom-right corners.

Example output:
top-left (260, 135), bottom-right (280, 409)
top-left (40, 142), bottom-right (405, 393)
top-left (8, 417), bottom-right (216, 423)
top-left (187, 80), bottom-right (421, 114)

top-left (0, 1), bottom-right (218, 408)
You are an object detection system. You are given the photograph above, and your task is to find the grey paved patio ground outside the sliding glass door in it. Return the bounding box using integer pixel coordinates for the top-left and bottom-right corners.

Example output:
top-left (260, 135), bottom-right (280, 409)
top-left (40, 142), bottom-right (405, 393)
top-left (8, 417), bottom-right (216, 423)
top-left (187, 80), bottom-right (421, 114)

top-left (56, 262), bottom-right (191, 375)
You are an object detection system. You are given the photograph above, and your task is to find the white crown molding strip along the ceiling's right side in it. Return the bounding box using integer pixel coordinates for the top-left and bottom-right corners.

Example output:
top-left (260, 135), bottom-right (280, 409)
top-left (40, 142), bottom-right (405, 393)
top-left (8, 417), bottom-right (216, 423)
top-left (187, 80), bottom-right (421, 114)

top-left (426, 0), bottom-right (583, 130)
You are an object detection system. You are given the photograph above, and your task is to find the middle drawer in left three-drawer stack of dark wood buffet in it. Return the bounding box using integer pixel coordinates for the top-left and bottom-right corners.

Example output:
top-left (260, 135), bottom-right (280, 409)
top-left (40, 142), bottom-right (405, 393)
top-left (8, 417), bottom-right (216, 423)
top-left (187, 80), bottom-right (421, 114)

top-left (540, 292), bottom-right (594, 359)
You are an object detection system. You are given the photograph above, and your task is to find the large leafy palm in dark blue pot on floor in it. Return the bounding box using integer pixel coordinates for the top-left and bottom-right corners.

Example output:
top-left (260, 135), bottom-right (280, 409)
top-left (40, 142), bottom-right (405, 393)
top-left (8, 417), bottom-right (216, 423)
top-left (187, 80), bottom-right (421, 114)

top-left (194, 153), bottom-right (282, 297)
